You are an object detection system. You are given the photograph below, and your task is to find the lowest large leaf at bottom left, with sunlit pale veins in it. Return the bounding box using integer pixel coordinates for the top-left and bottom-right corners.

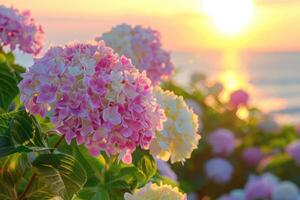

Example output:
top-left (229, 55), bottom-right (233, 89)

top-left (30, 154), bottom-right (87, 199)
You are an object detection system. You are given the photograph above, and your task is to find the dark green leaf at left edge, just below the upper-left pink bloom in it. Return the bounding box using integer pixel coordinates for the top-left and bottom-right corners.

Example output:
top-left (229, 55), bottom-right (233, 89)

top-left (0, 62), bottom-right (20, 110)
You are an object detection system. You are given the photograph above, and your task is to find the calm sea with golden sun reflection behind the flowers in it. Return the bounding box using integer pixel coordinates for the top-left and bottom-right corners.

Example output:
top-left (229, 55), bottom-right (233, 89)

top-left (17, 50), bottom-right (300, 123)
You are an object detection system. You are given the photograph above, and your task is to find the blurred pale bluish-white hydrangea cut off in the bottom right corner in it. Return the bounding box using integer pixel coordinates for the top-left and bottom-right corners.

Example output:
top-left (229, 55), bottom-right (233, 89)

top-left (272, 181), bottom-right (300, 200)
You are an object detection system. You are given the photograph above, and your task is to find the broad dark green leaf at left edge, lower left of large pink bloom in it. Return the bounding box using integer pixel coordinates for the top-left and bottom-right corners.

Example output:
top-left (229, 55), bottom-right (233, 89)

top-left (0, 111), bottom-right (48, 157)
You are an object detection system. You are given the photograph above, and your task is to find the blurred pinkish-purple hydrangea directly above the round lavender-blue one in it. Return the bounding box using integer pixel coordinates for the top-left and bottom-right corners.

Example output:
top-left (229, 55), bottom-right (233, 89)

top-left (207, 129), bottom-right (236, 156)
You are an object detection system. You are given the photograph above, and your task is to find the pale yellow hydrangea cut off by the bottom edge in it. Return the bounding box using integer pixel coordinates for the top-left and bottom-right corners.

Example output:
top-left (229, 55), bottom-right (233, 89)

top-left (124, 183), bottom-right (187, 200)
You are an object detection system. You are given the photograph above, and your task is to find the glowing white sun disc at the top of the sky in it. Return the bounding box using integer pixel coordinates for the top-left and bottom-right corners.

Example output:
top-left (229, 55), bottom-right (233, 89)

top-left (200, 0), bottom-right (254, 35)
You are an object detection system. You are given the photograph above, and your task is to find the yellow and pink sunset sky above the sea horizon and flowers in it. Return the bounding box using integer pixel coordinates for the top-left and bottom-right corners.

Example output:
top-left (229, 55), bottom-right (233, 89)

top-left (0, 0), bottom-right (300, 51)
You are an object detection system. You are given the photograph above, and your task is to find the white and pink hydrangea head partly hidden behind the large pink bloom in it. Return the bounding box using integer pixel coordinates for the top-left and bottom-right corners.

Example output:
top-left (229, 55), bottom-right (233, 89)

top-left (96, 24), bottom-right (174, 85)
